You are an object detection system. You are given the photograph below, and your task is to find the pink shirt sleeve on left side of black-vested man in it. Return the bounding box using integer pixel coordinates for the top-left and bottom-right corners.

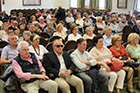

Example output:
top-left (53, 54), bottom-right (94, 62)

top-left (12, 60), bottom-right (31, 80)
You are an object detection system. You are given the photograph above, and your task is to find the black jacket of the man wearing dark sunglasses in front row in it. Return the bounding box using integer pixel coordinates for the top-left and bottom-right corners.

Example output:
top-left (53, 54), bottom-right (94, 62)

top-left (42, 51), bottom-right (75, 79)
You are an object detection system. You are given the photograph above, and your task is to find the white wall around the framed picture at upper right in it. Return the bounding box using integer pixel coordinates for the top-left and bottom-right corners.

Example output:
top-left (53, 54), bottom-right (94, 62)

top-left (112, 0), bottom-right (135, 14)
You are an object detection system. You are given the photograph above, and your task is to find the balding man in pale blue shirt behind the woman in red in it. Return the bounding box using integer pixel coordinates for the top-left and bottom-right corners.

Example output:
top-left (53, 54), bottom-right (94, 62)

top-left (103, 26), bottom-right (113, 46)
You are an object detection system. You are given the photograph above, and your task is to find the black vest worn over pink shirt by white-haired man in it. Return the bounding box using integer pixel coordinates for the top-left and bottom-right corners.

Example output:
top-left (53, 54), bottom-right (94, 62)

top-left (15, 53), bottom-right (41, 83)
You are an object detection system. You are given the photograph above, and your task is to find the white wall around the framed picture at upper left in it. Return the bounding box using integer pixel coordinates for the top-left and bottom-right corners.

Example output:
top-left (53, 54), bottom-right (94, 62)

top-left (1, 0), bottom-right (70, 14)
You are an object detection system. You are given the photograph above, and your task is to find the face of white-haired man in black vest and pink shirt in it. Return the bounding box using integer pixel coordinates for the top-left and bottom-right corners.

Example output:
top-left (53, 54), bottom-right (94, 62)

top-left (18, 44), bottom-right (30, 58)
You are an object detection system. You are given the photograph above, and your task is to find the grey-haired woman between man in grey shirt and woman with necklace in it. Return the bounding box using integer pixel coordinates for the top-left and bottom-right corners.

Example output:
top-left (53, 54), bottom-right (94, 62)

top-left (18, 31), bottom-right (32, 45)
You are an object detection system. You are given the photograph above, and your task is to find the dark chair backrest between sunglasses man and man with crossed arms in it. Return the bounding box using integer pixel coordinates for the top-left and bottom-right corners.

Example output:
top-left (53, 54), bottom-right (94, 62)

top-left (64, 40), bottom-right (76, 51)
